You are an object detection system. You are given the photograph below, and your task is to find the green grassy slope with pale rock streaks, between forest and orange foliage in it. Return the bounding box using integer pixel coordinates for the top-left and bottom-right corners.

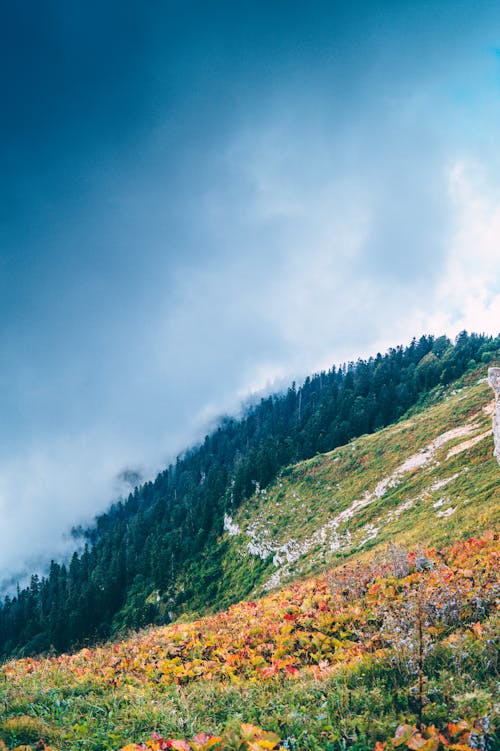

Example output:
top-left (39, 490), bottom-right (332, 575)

top-left (213, 368), bottom-right (500, 604)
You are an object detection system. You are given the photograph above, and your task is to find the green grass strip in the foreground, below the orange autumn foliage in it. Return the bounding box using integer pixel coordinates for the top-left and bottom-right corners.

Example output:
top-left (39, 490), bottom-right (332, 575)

top-left (0, 612), bottom-right (498, 751)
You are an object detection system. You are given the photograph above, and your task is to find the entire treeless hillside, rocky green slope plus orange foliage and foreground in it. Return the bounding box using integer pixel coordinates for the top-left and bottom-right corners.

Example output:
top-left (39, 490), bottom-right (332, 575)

top-left (0, 352), bottom-right (500, 751)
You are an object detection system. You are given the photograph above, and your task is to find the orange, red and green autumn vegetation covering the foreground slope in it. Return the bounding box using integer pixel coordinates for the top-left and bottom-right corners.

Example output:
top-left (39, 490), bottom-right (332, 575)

top-left (0, 534), bottom-right (500, 751)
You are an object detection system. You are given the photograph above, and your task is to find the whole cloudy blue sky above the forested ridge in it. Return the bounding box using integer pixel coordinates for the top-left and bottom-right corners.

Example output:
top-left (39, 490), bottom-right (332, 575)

top-left (0, 0), bottom-right (500, 582)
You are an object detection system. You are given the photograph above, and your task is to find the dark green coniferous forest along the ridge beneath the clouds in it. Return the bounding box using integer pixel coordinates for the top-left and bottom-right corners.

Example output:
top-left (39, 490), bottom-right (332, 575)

top-left (0, 332), bottom-right (500, 658)
